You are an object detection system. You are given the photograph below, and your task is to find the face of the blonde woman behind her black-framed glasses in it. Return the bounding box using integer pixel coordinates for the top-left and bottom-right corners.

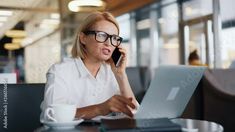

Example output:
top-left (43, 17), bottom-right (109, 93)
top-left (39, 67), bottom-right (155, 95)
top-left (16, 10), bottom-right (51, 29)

top-left (82, 20), bottom-right (118, 61)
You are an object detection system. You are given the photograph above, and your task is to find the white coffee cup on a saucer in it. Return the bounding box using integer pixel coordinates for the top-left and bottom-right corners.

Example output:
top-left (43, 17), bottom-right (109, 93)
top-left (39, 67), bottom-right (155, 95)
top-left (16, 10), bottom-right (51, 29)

top-left (45, 104), bottom-right (76, 122)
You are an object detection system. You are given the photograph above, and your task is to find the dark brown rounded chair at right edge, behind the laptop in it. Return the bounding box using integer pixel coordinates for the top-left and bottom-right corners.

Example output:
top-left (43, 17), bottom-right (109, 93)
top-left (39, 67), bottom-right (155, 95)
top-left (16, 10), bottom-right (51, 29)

top-left (203, 69), bottom-right (235, 132)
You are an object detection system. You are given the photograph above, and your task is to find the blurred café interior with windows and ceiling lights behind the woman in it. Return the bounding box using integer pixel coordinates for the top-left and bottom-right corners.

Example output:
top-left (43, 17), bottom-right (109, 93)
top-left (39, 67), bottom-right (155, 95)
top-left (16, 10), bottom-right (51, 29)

top-left (0, 0), bottom-right (235, 83)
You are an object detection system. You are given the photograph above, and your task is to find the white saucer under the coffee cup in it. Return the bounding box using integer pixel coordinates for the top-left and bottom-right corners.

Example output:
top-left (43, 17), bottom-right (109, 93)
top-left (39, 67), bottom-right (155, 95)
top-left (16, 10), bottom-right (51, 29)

top-left (41, 119), bottom-right (84, 129)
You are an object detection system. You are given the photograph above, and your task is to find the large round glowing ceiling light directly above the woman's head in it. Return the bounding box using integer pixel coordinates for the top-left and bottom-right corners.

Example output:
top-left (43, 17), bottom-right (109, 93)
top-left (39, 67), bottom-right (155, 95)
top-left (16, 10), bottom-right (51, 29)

top-left (68, 0), bottom-right (105, 12)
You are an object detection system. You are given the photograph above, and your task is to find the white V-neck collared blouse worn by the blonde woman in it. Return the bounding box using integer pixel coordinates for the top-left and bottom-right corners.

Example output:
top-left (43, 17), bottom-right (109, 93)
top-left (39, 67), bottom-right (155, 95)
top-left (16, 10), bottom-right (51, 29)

top-left (41, 58), bottom-right (120, 117)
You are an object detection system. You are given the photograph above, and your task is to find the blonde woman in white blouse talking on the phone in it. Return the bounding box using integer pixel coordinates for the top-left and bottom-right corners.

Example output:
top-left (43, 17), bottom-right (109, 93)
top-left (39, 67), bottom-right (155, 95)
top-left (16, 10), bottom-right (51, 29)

top-left (42, 12), bottom-right (138, 119)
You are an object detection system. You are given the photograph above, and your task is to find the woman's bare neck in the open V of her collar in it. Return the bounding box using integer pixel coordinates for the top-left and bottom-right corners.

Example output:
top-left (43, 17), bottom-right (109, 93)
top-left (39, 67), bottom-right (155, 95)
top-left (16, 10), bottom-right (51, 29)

top-left (82, 58), bottom-right (102, 77)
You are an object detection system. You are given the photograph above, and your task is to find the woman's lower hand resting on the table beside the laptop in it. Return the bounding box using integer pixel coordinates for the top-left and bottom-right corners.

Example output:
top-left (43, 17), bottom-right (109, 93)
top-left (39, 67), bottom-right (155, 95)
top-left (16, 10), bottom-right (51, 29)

top-left (98, 95), bottom-right (135, 117)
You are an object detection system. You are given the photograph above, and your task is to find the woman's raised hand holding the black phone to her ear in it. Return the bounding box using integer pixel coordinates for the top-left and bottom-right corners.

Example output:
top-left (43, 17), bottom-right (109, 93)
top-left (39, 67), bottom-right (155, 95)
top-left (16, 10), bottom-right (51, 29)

top-left (108, 46), bottom-right (127, 75)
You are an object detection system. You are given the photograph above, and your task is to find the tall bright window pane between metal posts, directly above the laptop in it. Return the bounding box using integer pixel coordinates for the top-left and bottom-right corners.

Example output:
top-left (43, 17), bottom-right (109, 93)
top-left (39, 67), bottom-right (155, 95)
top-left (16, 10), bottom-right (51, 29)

top-left (158, 3), bottom-right (179, 64)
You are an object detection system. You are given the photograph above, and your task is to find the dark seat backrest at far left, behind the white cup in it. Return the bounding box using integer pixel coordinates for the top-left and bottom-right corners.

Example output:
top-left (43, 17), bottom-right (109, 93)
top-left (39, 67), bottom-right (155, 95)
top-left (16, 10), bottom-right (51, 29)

top-left (0, 84), bottom-right (45, 132)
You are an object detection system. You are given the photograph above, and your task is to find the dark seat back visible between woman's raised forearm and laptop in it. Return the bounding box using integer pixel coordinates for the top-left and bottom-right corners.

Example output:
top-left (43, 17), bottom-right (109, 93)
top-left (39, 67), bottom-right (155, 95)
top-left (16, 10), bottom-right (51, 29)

top-left (126, 67), bottom-right (150, 103)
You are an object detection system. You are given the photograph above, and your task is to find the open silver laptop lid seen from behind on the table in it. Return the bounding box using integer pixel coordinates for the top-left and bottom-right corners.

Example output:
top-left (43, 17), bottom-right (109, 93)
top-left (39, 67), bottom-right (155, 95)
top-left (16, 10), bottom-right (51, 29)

top-left (134, 65), bottom-right (206, 119)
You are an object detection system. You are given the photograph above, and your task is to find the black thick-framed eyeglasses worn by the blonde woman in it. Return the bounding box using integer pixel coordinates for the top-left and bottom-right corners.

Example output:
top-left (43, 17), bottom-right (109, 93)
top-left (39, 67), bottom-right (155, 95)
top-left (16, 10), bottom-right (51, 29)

top-left (84, 31), bottom-right (122, 47)
